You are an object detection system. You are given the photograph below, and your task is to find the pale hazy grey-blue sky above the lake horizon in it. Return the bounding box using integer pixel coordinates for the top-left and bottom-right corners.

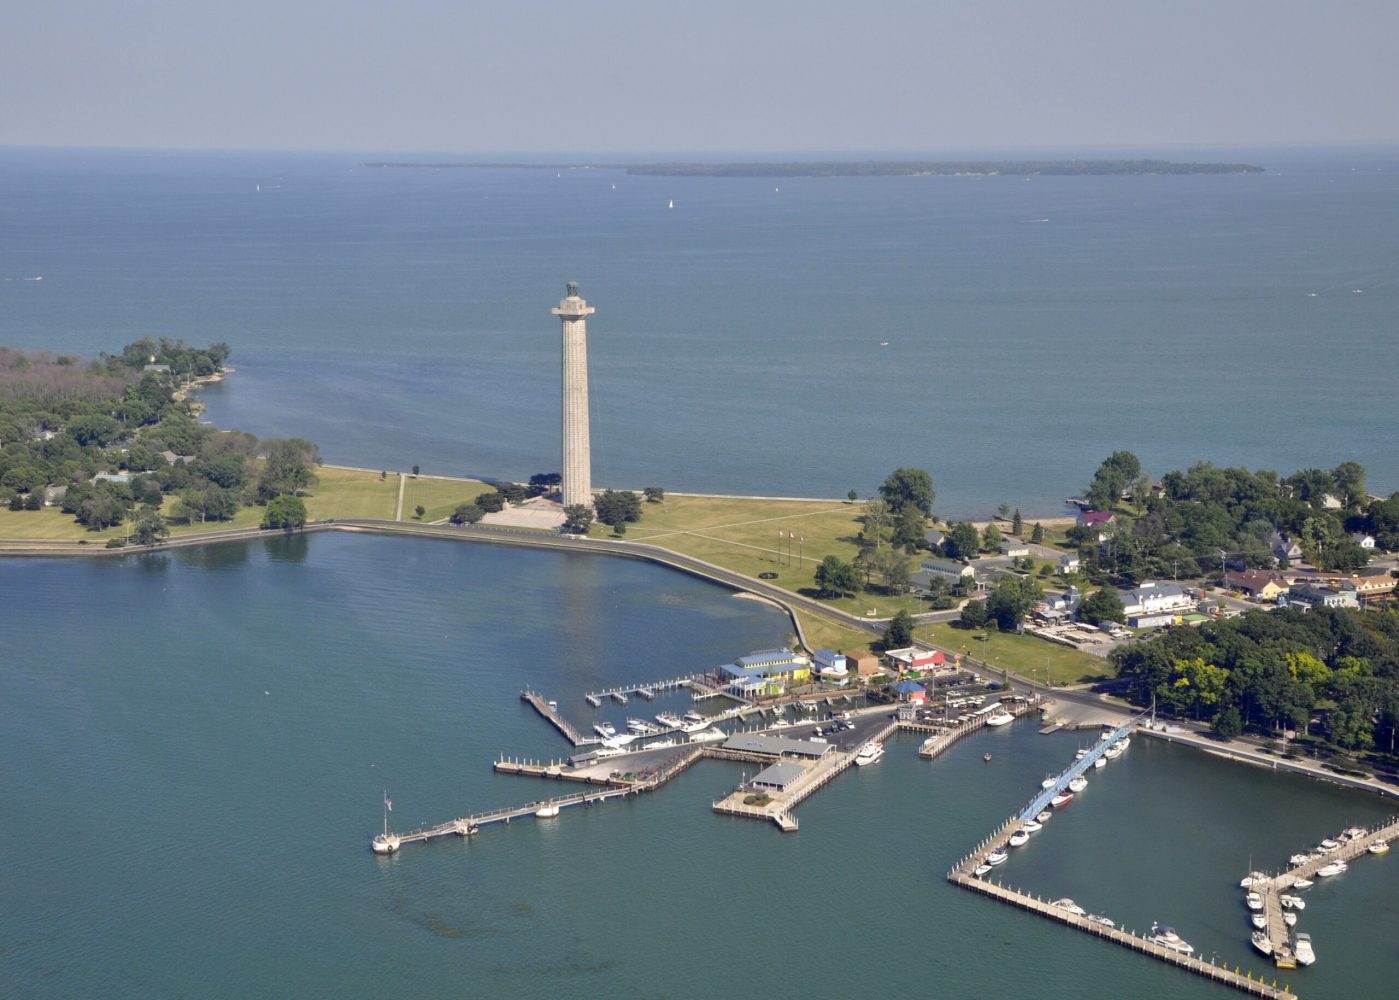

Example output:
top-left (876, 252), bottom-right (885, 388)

top-left (0, 0), bottom-right (1399, 154)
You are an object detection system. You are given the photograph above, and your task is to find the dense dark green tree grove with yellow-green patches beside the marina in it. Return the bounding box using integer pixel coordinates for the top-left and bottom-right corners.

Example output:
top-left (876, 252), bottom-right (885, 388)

top-left (1112, 608), bottom-right (1399, 751)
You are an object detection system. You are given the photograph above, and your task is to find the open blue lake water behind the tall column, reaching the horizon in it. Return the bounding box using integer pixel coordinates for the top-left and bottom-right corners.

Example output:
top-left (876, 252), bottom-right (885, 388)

top-left (0, 148), bottom-right (1399, 516)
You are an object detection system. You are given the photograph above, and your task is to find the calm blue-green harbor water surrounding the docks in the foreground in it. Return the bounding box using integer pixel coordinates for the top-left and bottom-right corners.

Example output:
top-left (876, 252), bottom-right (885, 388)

top-left (0, 536), bottom-right (1399, 1000)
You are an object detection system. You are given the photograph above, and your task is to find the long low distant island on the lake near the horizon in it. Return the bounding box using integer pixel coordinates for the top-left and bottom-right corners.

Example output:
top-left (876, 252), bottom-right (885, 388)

top-left (361, 159), bottom-right (1263, 178)
